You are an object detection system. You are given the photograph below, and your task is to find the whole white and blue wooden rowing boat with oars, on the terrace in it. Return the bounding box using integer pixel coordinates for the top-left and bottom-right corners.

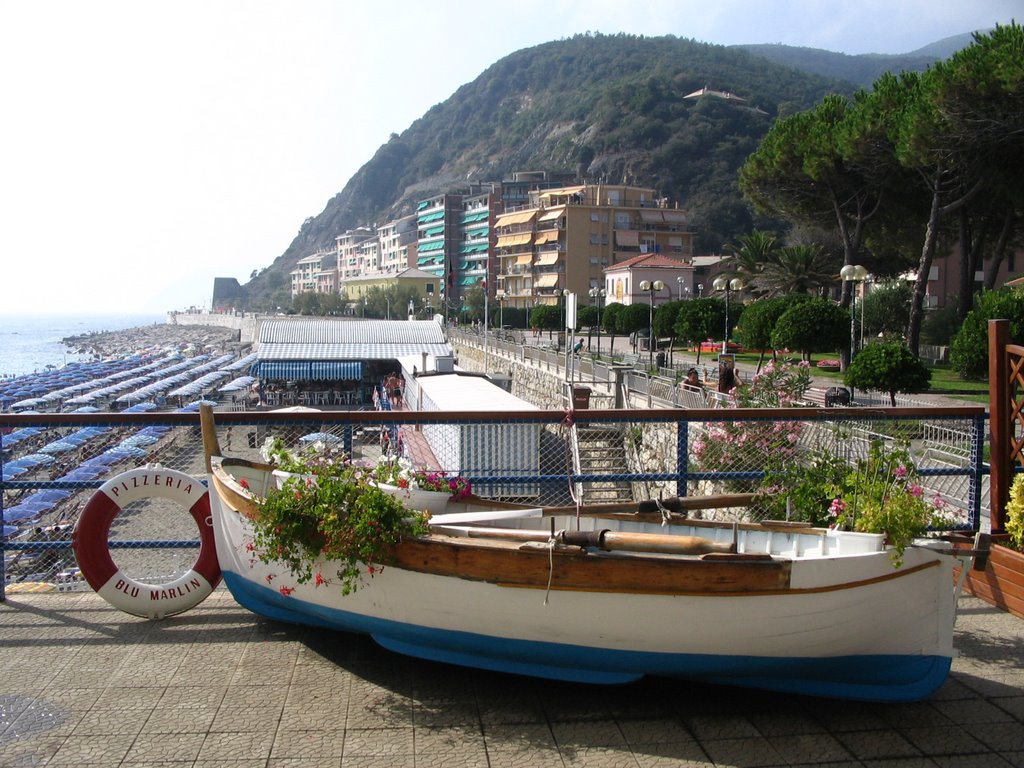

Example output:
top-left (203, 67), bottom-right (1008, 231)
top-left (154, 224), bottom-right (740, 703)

top-left (195, 409), bottom-right (967, 701)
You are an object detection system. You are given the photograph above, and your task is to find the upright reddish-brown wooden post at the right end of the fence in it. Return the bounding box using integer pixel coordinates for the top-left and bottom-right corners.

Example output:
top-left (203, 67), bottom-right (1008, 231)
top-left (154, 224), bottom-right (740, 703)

top-left (988, 319), bottom-right (1013, 532)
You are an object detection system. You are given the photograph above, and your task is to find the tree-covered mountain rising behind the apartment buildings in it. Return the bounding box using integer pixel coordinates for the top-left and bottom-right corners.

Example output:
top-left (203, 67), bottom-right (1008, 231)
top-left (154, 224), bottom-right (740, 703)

top-left (237, 34), bottom-right (971, 303)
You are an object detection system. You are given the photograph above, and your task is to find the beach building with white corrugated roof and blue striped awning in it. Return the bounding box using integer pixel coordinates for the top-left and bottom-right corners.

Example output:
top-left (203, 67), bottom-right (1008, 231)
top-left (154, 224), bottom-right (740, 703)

top-left (251, 317), bottom-right (453, 408)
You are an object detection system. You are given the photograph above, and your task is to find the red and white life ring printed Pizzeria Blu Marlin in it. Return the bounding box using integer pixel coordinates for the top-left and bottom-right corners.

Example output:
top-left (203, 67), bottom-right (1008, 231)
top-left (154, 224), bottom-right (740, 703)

top-left (72, 464), bottom-right (220, 618)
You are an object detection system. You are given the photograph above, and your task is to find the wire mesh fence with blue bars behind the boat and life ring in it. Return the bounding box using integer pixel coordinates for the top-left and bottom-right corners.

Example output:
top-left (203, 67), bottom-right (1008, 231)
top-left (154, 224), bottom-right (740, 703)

top-left (0, 407), bottom-right (987, 590)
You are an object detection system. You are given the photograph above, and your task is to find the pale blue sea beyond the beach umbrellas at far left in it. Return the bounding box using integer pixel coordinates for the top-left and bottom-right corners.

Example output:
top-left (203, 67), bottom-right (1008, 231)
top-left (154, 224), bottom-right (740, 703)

top-left (0, 314), bottom-right (167, 377)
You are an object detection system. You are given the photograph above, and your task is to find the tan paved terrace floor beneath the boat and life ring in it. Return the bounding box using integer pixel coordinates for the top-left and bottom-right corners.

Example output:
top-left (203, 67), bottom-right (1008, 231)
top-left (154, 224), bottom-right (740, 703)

top-left (0, 588), bottom-right (1024, 768)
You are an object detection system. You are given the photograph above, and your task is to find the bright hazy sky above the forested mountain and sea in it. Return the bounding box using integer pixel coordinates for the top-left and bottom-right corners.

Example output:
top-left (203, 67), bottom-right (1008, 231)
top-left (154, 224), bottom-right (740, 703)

top-left (0, 0), bottom-right (1024, 315)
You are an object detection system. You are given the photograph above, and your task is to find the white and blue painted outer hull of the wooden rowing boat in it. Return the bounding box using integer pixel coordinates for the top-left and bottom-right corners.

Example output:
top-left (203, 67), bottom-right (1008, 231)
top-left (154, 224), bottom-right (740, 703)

top-left (211, 462), bottom-right (956, 700)
